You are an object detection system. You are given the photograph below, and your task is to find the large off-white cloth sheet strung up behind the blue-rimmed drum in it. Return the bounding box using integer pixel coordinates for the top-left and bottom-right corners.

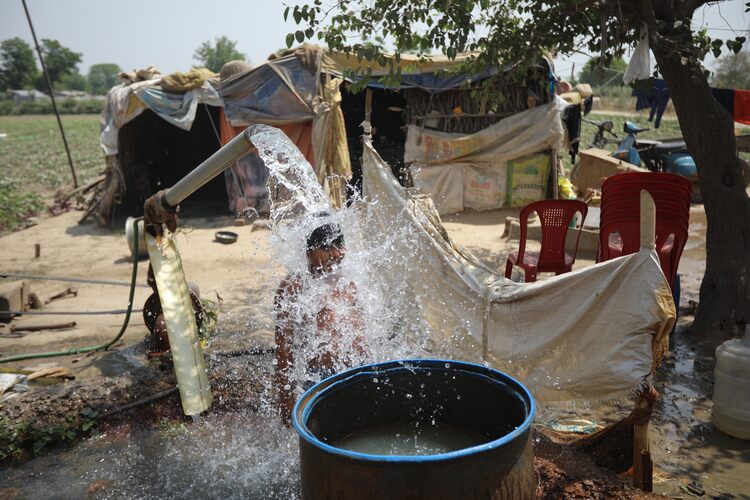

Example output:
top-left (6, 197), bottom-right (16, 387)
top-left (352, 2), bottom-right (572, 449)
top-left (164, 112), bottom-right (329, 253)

top-left (363, 136), bottom-right (675, 402)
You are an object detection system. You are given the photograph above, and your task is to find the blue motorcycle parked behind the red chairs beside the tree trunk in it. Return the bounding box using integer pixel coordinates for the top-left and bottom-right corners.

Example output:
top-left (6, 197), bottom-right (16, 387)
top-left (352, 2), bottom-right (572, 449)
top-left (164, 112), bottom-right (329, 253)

top-left (584, 119), bottom-right (701, 203)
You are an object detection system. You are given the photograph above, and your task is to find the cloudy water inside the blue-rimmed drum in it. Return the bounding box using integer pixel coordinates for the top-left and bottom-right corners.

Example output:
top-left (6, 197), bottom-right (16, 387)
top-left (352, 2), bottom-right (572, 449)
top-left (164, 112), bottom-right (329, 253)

top-left (332, 423), bottom-right (488, 455)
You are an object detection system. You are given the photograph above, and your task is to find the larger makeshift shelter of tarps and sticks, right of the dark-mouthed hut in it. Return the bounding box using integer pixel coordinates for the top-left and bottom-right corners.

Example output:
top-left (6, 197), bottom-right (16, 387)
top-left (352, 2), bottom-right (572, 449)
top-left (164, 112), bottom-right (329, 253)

top-left (217, 44), bottom-right (563, 217)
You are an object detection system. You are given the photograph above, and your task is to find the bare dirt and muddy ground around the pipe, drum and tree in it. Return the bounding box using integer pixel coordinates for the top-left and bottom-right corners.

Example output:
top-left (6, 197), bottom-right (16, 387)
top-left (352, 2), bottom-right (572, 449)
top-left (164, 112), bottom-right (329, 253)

top-left (0, 206), bottom-right (750, 498)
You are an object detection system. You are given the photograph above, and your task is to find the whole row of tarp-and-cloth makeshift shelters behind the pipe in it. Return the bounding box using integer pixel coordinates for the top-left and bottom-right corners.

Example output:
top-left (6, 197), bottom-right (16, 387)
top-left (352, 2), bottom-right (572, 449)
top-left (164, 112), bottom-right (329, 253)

top-left (97, 44), bottom-right (562, 223)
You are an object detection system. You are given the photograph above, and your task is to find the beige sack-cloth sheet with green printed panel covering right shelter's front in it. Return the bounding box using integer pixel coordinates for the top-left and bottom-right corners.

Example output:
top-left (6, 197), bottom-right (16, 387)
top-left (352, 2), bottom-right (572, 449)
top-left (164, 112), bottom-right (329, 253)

top-left (412, 102), bottom-right (564, 214)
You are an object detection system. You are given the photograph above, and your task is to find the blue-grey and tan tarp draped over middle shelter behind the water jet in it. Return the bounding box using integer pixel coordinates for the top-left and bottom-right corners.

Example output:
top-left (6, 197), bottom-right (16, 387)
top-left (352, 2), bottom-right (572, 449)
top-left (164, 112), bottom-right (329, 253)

top-left (217, 45), bottom-right (352, 212)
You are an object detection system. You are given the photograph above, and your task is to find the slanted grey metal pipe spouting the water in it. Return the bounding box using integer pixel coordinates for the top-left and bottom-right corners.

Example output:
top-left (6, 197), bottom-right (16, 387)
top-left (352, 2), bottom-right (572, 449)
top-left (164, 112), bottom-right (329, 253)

top-left (163, 125), bottom-right (255, 208)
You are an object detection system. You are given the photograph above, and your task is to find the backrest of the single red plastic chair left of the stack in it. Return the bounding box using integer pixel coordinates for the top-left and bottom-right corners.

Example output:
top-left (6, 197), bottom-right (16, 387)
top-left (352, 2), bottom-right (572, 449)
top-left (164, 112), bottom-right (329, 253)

top-left (518, 200), bottom-right (588, 269)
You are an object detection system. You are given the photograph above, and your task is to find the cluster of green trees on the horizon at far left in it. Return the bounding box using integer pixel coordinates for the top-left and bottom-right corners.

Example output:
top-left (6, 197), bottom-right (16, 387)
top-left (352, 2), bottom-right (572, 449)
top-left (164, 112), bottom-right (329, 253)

top-left (0, 37), bottom-right (121, 95)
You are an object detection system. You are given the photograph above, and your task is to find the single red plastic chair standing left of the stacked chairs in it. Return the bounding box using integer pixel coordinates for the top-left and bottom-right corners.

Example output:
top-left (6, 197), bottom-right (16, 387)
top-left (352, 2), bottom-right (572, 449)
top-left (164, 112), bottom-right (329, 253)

top-left (505, 200), bottom-right (588, 283)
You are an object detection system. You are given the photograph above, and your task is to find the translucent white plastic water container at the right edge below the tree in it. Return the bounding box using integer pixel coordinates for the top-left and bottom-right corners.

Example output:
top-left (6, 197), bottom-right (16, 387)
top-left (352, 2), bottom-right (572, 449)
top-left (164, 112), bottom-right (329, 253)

top-left (712, 325), bottom-right (750, 440)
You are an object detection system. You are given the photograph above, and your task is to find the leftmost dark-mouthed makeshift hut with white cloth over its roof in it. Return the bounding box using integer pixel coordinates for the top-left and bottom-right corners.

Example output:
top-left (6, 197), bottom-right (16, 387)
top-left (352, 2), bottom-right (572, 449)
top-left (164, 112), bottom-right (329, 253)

top-left (90, 67), bottom-right (226, 224)
